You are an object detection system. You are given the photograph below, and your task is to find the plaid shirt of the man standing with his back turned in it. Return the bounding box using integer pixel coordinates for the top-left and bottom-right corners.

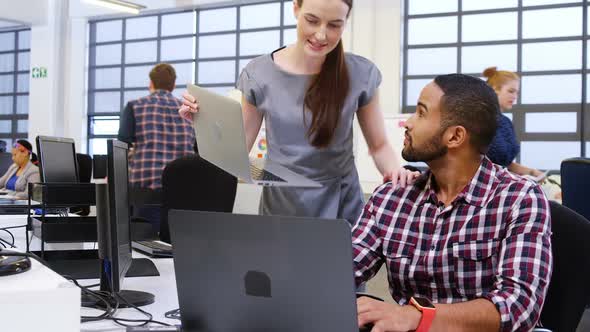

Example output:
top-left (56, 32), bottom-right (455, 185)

top-left (128, 90), bottom-right (195, 189)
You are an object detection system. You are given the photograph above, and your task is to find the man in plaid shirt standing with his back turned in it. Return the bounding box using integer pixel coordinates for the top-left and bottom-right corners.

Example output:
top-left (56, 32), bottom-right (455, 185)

top-left (118, 63), bottom-right (196, 229)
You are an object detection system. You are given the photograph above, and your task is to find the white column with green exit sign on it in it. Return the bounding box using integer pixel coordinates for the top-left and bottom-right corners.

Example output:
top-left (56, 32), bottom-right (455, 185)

top-left (29, 0), bottom-right (88, 152)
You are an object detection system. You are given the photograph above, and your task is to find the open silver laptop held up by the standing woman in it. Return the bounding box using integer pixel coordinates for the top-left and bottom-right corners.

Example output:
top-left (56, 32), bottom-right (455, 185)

top-left (188, 84), bottom-right (321, 187)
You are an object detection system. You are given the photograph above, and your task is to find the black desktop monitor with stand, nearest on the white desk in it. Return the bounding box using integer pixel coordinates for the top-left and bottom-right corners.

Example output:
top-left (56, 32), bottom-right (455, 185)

top-left (96, 140), bottom-right (154, 307)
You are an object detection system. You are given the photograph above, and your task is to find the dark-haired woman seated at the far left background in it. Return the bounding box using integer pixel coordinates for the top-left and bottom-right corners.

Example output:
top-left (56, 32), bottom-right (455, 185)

top-left (0, 139), bottom-right (39, 199)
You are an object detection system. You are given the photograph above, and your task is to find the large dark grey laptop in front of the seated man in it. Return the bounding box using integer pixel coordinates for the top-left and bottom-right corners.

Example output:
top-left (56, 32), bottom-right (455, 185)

top-left (169, 210), bottom-right (359, 332)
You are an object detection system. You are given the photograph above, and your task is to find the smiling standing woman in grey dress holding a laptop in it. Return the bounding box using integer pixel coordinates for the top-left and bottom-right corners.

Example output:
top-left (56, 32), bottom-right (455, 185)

top-left (179, 0), bottom-right (416, 223)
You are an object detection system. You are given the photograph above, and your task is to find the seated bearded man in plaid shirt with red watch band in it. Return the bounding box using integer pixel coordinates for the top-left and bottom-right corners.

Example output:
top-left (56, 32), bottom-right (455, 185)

top-left (352, 74), bottom-right (552, 331)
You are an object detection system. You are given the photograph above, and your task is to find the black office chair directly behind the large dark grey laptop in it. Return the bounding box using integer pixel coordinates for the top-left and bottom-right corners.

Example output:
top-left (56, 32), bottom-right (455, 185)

top-left (160, 155), bottom-right (238, 243)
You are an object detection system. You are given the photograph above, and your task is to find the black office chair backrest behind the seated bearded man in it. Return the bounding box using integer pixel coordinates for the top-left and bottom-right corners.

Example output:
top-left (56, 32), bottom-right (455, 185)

top-left (541, 201), bottom-right (590, 332)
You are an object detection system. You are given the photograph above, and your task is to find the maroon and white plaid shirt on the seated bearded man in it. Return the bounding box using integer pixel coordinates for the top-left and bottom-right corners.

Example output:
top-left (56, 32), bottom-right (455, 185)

top-left (352, 157), bottom-right (552, 331)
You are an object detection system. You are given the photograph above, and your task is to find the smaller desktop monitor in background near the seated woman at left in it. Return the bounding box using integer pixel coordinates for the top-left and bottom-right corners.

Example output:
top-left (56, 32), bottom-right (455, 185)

top-left (36, 136), bottom-right (79, 183)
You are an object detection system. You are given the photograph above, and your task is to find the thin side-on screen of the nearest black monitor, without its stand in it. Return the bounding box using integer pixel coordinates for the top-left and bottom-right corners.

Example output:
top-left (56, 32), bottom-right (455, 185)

top-left (107, 140), bottom-right (131, 292)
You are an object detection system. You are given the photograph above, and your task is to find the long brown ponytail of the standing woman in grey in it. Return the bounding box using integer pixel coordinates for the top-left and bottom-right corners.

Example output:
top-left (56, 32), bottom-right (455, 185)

top-left (297, 0), bottom-right (353, 148)
